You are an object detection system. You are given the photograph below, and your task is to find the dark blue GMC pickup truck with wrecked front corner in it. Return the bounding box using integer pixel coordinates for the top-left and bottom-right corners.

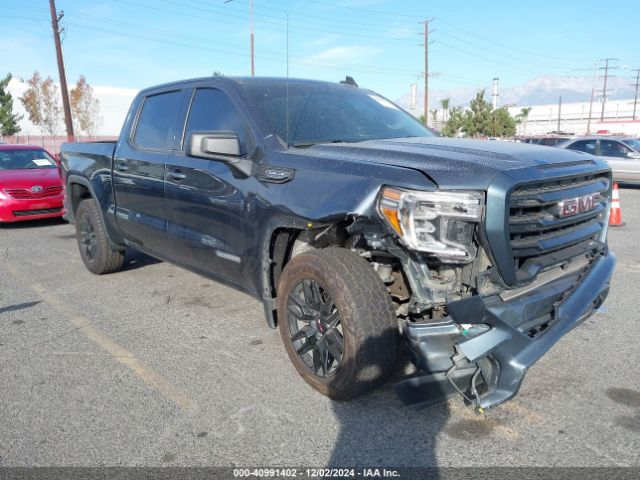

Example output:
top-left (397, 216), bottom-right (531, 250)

top-left (61, 77), bottom-right (614, 408)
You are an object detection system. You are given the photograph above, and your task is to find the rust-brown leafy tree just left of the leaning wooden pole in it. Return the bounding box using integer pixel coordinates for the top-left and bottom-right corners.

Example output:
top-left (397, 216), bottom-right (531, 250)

top-left (20, 71), bottom-right (62, 136)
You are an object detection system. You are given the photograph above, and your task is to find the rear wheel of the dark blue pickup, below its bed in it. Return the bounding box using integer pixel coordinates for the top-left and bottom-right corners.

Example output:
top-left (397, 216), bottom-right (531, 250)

top-left (75, 198), bottom-right (124, 275)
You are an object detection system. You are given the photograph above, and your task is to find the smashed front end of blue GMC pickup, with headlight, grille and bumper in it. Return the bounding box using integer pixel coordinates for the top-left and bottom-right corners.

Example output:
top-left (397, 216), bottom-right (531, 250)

top-left (376, 166), bottom-right (615, 409)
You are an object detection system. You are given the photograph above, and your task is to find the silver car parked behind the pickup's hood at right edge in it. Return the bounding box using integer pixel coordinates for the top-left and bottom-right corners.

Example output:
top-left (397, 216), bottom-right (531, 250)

top-left (556, 137), bottom-right (640, 183)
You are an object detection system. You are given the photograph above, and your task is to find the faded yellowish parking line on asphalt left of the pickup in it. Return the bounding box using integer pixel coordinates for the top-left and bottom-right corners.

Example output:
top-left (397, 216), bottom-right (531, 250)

top-left (3, 261), bottom-right (191, 409)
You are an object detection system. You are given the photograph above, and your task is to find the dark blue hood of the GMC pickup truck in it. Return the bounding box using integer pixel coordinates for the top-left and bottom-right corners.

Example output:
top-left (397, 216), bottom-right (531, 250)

top-left (305, 137), bottom-right (594, 190)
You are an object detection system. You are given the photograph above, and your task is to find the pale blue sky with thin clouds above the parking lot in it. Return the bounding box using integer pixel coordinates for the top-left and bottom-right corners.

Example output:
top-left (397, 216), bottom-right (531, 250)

top-left (0, 0), bottom-right (640, 99)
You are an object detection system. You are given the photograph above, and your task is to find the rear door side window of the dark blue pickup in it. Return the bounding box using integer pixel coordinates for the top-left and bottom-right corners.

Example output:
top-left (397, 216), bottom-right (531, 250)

top-left (133, 90), bottom-right (183, 150)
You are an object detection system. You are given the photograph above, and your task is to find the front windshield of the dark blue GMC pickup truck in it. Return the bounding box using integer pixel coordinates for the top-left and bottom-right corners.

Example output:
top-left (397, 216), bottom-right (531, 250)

top-left (243, 83), bottom-right (433, 147)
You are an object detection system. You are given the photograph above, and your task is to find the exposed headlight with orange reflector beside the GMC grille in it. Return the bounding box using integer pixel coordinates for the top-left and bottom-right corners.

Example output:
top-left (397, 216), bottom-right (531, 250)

top-left (378, 187), bottom-right (484, 262)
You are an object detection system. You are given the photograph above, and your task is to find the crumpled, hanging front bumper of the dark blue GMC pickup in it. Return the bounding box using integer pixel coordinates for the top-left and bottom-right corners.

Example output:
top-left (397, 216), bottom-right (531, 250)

top-left (396, 252), bottom-right (615, 408)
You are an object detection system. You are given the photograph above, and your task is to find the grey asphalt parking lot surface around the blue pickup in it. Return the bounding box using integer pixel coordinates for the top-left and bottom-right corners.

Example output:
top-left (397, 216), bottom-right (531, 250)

top-left (0, 189), bottom-right (640, 466)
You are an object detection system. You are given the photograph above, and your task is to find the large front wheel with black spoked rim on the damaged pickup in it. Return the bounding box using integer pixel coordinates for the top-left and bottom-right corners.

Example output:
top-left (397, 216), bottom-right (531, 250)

top-left (277, 248), bottom-right (398, 400)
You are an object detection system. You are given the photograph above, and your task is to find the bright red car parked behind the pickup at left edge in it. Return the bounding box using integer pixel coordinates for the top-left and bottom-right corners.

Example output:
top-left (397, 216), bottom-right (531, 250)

top-left (0, 145), bottom-right (64, 223)
